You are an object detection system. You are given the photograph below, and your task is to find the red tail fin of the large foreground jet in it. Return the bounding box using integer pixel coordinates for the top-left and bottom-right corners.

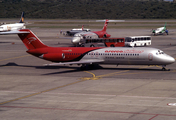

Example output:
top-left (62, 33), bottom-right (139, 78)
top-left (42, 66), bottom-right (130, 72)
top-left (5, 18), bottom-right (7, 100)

top-left (18, 29), bottom-right (47, 50)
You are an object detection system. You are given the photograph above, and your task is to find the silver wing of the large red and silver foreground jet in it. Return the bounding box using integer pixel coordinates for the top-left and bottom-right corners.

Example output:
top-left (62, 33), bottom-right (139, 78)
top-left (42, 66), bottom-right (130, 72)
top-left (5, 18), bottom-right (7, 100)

top-left (45, 59), bottom-right (104, 66)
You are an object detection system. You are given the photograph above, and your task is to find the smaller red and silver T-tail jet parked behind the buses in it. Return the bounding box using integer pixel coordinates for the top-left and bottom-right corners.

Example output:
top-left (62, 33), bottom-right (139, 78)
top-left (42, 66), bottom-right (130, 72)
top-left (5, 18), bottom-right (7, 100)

top-left (71, 20), bottom-right (124, 46)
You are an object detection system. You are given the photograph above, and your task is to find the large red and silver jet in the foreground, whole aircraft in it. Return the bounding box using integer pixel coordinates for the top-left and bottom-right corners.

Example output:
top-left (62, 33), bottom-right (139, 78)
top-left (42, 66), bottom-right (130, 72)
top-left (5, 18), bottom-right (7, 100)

top-left (14, 29), bottom-right (175, 70)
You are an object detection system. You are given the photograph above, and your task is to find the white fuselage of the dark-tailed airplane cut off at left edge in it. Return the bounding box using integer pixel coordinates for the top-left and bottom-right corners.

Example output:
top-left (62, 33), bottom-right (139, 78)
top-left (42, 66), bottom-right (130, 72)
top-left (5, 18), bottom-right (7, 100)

top-left (0, 23), bottom-right (25, 32)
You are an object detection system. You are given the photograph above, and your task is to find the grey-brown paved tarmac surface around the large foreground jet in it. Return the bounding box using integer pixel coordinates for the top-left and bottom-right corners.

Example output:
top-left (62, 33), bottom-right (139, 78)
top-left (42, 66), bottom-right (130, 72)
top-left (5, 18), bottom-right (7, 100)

top-left (0, 20), bottom-right (176, 120)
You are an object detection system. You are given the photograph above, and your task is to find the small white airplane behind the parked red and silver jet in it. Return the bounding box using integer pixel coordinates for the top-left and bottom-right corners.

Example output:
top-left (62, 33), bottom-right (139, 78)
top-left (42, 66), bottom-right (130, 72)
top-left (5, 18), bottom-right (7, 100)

top-left (62, 25), bottom-right (91, 36)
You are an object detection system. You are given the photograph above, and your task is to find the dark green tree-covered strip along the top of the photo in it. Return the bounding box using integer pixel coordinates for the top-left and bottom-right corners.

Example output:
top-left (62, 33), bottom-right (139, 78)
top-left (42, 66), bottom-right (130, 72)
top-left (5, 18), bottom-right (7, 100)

top-left (0, 0), bottom-right (176, 19)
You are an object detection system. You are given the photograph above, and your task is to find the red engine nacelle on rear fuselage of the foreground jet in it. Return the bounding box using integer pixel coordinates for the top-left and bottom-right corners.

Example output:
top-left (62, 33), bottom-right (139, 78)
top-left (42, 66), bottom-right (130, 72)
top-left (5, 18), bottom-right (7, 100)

top-left (40, 53), bottom-right (65, 62)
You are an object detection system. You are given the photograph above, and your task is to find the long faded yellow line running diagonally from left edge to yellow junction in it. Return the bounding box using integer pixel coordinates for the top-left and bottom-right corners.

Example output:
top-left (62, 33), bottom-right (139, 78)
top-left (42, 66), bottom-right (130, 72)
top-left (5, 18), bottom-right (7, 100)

top-left (0, 80), bottom-right (85, 105)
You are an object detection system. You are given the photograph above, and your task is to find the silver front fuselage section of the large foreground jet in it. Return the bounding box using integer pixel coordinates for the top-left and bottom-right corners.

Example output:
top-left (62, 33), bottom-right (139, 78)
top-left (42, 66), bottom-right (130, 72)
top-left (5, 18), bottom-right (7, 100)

top-left (81, 47), bottom-right (175, 65)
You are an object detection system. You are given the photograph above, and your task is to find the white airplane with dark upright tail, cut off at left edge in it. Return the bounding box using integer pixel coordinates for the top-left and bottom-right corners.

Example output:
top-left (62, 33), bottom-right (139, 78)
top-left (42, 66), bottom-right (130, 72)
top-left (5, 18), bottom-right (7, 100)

top-left (0, 12), bottom-right (26, 34)
